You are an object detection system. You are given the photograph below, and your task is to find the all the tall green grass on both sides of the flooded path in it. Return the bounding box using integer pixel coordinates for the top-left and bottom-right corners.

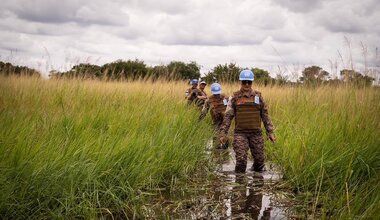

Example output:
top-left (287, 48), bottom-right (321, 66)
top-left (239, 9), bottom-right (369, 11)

top-left (0, 77), bottom-right (380, 219)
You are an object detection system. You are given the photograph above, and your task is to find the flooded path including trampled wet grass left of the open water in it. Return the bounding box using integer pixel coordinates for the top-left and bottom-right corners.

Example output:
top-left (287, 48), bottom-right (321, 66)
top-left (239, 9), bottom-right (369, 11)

top-left (145, 150), bottom-right (287, 219)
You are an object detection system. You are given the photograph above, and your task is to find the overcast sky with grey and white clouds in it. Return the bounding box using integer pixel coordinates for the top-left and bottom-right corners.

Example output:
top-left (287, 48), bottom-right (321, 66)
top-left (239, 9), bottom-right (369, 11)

top-left (0, 0), bottom-right (380, 78)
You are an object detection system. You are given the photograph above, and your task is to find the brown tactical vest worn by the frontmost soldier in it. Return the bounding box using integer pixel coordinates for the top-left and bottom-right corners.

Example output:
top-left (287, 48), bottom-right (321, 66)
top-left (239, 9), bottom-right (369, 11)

top-left (235, 96), bottom-right (261, 129)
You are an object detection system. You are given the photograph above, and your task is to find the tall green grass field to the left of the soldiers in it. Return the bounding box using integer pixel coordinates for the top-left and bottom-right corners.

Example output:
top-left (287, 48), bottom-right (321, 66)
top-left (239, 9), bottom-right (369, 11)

top-left (0, 77), bottom-right (212, 219)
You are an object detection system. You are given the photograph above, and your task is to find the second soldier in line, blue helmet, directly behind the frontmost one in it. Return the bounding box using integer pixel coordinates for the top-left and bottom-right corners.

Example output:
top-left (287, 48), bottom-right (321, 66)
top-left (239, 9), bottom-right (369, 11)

top-left (199, 83), bottom-right (228, 148)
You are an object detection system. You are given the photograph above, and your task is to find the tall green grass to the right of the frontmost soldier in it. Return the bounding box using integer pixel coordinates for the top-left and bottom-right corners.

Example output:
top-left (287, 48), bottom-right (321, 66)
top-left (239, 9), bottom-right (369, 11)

top-left (264, 86), bottom-right (380, 219)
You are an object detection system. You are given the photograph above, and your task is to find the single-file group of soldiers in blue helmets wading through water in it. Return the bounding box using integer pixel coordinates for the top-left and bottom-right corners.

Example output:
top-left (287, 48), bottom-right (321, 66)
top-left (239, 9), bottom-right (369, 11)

top-left (186, 70), bottom-right (276, 173)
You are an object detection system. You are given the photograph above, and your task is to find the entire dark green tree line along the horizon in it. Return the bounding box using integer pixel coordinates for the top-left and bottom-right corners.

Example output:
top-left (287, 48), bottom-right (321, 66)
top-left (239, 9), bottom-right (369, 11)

top-left (0, 59), bottom-right (374, 86)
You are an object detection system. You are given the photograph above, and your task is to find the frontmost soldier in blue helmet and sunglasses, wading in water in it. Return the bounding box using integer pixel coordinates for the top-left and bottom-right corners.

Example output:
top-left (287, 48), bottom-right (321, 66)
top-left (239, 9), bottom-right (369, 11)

top-left (220, 70), bottom-right (276, 173)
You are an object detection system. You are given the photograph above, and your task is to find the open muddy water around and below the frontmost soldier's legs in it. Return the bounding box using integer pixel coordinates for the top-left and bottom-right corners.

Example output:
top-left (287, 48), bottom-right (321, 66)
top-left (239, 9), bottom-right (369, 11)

top-left (212, 149), bottom-right (286, 219)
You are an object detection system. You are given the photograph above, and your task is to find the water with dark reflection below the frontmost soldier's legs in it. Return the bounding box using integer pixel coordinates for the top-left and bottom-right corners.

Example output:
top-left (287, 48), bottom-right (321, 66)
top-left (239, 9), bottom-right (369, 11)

top-left (213, 150), bottom-right (286, 220)
